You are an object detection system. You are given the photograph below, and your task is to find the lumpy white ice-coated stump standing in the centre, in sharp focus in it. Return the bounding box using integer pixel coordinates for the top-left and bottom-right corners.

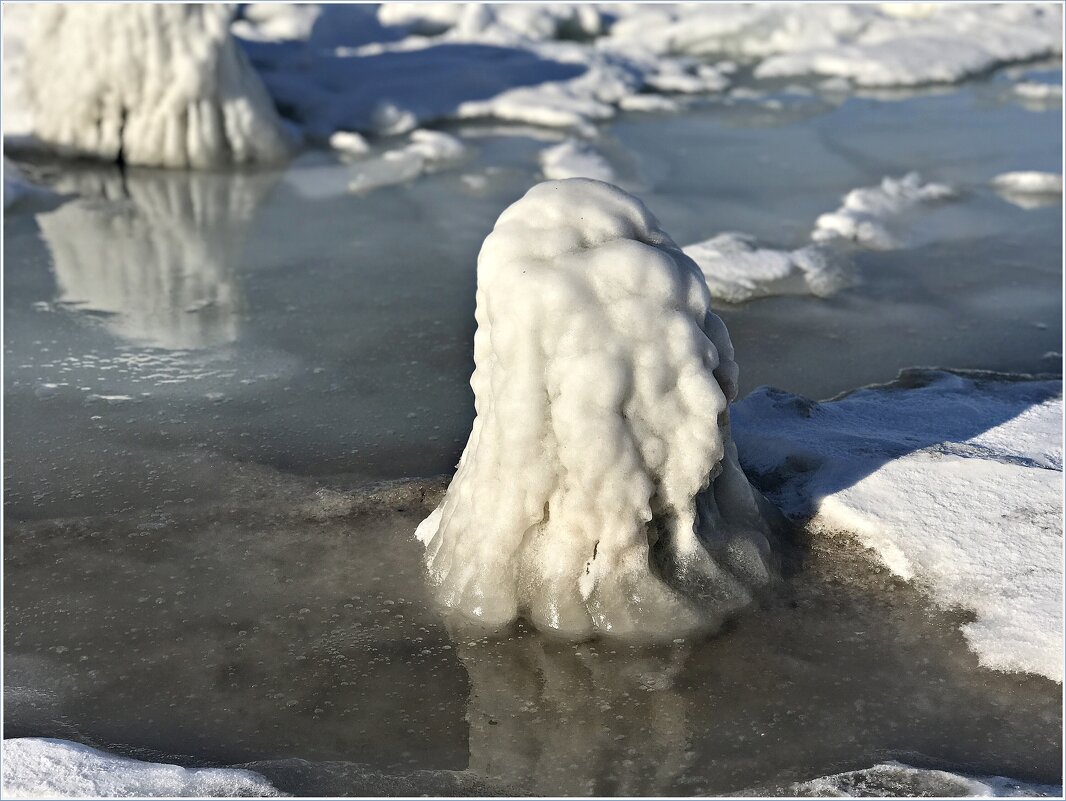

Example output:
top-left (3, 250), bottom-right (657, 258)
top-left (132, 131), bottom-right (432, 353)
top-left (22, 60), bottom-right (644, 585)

top-left (418, 178), bottom-right (769, 636)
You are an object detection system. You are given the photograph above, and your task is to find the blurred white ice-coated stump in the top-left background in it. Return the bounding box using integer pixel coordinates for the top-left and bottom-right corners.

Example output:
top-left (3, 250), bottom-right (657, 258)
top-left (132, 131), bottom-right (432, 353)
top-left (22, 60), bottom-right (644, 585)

top-left (4, 3), bottom-right (290, 169)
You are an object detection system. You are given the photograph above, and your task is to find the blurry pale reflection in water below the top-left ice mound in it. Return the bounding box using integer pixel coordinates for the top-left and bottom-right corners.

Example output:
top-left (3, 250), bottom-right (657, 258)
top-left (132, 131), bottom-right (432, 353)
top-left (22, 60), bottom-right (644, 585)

top-left (37, 171), bottom-right (274, 350)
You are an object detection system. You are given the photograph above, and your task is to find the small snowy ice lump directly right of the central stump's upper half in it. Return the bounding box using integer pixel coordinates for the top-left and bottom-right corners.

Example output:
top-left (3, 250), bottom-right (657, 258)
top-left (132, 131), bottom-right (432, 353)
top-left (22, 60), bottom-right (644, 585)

top-left (684, 234), bottom-right (845, 303)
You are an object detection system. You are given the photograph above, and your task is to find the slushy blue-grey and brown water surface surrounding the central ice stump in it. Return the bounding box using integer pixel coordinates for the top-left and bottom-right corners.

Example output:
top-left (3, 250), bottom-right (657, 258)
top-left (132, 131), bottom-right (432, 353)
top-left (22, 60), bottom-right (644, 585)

top-left (4, 51), bottom-right (1062, 795)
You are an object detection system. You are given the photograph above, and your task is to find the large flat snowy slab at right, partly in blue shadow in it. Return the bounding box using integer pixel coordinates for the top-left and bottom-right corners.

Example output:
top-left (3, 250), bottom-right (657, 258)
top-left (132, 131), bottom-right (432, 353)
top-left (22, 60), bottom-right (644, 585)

top-left (733, 370), bottom-right (1063, 682)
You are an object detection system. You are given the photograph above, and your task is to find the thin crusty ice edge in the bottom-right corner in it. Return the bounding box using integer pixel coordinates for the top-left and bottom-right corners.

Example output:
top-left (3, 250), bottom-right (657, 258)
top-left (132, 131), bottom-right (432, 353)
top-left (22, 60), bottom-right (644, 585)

top-left (781, 762), bottom-right (1063, 798)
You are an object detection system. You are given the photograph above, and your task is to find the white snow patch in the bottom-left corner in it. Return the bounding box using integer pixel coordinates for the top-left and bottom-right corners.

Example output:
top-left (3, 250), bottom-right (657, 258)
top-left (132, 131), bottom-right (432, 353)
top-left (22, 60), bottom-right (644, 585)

top-left (0, 737), bottom-right (281, 798)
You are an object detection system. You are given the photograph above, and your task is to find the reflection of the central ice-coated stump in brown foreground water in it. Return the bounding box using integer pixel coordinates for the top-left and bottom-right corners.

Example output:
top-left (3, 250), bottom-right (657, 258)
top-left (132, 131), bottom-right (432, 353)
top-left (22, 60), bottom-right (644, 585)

top-left (458, 636), bottom-right (697, 797)
